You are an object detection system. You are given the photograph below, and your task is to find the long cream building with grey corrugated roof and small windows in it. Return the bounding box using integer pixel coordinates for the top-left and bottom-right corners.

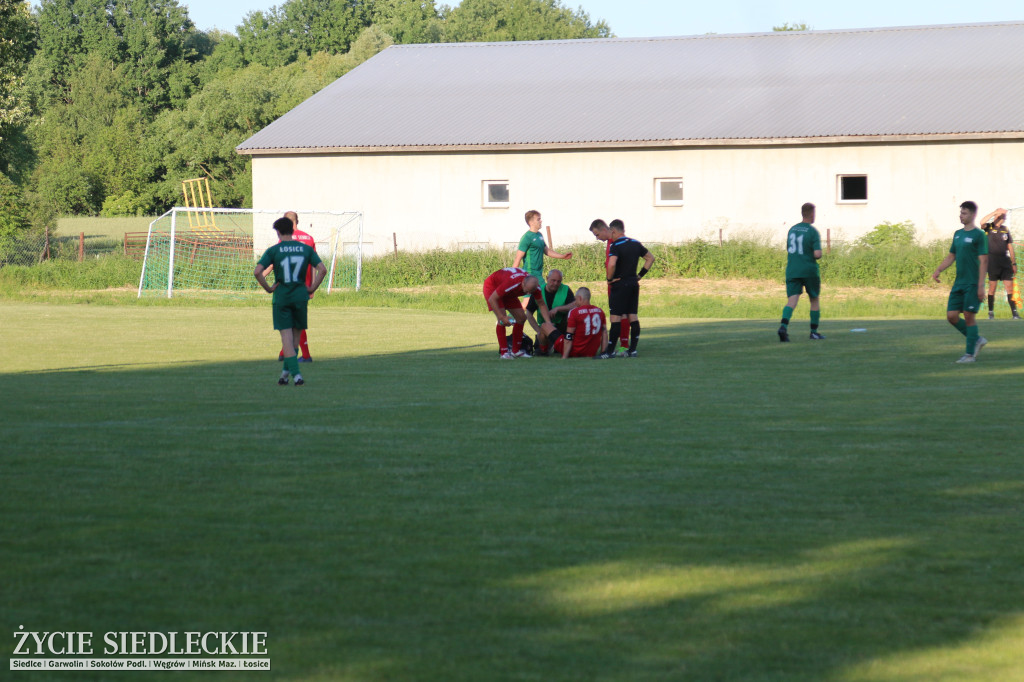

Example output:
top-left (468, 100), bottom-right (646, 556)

top-left (238, 22), bottom-right (1024, 254)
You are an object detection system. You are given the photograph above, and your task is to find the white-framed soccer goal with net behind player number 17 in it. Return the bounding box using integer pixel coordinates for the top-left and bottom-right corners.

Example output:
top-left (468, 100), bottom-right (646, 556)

top-left (138, 207), bottom-right (362, 298)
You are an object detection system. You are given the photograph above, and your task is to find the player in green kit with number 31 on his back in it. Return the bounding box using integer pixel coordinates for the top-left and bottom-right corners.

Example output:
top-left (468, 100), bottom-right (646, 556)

top-left (778, 204), bottom-right (825, 342)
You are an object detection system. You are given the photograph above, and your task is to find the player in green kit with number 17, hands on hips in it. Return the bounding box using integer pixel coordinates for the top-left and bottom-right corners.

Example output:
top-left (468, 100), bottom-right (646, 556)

top-left (253, 218), bottom-right (327, 386)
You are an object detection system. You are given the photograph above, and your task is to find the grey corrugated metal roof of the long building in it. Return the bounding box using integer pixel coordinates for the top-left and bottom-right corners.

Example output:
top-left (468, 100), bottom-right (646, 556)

top-left (238, 22), bottom-right (1024, 154)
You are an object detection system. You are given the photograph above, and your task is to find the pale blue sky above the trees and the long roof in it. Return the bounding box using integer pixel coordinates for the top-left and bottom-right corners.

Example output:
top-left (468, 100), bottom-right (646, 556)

top-left (179, 0), bottom-right (1024, 38)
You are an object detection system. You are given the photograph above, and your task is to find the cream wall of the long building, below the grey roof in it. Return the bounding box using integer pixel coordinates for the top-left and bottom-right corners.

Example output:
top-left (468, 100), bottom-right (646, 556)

top-left (253, 140), bottom-right (1024, 255)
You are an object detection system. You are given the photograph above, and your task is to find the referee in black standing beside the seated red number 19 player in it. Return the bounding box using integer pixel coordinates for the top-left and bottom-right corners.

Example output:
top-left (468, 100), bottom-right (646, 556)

top-left (598, 220), bottom-right (654, 359)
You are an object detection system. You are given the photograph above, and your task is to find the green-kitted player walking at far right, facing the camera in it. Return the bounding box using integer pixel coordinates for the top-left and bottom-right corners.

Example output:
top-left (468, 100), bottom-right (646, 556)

top-left (932, 202), bottom-right (988, 365)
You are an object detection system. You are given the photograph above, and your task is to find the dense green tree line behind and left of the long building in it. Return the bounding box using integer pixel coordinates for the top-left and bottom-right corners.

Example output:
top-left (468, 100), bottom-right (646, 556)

top-left (0, 0), bottom-right (611, 233)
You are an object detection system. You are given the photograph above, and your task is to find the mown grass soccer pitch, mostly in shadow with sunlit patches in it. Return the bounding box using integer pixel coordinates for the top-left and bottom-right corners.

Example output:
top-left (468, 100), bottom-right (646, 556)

top-left (0, 301), bottom-right (1024, 682)
